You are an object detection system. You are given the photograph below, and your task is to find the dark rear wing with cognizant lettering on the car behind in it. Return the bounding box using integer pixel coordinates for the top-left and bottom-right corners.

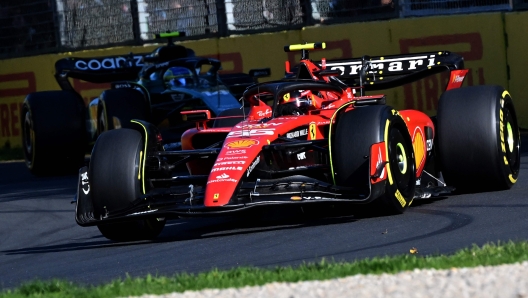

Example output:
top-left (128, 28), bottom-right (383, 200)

top-left (55, 53), bottom-right (149, 91)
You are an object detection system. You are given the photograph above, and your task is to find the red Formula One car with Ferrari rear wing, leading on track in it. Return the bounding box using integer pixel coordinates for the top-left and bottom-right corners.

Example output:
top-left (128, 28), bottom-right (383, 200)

top-left (76, 43), bottom-right (520, 241)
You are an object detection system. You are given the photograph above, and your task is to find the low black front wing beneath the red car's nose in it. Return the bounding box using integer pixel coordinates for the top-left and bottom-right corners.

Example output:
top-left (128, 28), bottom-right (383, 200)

top-left (75, 167), bottom-right (385, 226)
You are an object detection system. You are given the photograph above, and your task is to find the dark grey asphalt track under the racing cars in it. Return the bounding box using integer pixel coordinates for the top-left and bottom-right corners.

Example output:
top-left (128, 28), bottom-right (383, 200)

top-left (0, 138), bottom-right (528, 289)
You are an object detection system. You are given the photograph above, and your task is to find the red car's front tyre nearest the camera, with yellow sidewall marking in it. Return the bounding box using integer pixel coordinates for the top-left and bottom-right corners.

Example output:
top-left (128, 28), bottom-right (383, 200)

top-left (332, 105), bottom-right (416, 215)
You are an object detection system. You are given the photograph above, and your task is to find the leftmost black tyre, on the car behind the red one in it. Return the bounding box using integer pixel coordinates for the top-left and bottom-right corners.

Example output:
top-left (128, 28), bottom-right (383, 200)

top-left (20, 91), bottom-right (87, 175)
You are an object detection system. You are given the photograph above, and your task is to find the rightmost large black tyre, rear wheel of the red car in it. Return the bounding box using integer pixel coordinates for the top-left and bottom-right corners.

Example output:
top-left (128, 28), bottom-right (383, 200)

top-left (437, 86), bottom-right (520, 192)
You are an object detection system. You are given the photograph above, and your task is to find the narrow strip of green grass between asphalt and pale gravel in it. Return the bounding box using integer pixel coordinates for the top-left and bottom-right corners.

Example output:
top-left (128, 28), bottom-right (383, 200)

top-left (0, 242), bottom-right (528, 298)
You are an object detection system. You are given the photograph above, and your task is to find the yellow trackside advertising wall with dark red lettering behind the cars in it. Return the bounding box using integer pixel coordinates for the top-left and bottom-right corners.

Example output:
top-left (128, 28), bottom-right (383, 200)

top-left (0, 12), bottom-right (528, 146)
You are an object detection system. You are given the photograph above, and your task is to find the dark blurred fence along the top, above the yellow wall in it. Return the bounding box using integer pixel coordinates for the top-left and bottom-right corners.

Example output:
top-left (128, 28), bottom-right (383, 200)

top-left (0, 0), bottom-right (528, 59)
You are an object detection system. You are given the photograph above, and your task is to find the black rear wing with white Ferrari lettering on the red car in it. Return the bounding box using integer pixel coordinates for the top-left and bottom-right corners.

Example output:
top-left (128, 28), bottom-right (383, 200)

top-left (314, 51), bottom-right (464, 90)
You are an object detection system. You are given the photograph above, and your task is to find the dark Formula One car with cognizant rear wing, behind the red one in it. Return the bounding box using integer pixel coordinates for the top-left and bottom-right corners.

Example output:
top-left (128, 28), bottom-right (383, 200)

top-left (21, 33), bottom-right (270, 175)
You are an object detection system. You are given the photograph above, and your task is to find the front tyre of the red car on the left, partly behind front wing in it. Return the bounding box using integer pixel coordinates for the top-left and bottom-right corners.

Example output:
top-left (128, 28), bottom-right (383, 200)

top-left (89, 129), bottom-right (165, 241)
